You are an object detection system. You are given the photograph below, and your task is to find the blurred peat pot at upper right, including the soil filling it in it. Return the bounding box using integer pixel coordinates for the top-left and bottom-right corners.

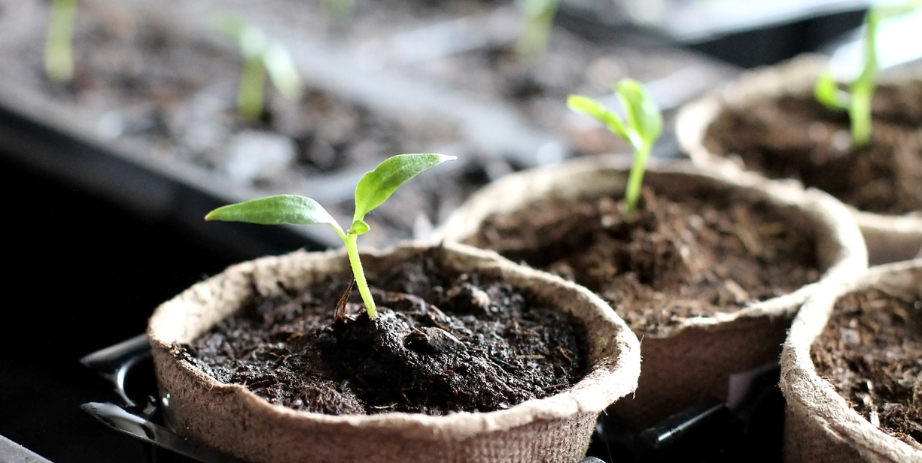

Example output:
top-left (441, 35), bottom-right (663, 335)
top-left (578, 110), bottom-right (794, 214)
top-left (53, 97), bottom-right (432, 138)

top-left (676, 55), bottom-right (922, 264)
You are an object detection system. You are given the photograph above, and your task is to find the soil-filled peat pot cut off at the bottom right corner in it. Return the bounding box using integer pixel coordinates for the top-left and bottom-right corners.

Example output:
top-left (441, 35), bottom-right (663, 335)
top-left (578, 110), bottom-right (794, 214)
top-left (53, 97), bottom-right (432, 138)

top-left (781, 260), bottom-right (922, 463)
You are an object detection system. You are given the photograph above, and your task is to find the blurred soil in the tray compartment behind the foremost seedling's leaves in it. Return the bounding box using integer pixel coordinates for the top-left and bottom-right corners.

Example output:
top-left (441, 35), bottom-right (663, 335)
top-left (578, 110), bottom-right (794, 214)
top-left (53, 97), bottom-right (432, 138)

top-left (0, 2), bottom-right (491, 245)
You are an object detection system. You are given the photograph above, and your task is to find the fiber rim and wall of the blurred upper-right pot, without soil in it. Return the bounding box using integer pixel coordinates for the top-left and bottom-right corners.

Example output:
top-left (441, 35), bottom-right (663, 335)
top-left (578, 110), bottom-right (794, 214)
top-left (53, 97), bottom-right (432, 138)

top-left (676, 55), bottom-right (922, 264)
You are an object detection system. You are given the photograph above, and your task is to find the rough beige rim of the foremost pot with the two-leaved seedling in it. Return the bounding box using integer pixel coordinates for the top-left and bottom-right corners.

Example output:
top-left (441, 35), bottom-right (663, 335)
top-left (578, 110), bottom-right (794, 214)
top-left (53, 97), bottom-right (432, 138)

top-left (148, 243), bottom-right (640, 440)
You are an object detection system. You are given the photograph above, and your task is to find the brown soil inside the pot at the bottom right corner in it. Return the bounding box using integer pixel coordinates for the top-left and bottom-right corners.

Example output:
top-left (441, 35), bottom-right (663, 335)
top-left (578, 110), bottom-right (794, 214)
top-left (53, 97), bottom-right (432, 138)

top-left (810, 289), bottom-right (922, 450)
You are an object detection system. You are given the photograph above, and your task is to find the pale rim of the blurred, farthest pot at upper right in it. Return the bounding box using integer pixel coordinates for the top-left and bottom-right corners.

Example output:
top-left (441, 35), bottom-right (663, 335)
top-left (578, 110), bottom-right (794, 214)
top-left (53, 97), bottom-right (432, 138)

top-left (675, 53), bottom-right (922, 260)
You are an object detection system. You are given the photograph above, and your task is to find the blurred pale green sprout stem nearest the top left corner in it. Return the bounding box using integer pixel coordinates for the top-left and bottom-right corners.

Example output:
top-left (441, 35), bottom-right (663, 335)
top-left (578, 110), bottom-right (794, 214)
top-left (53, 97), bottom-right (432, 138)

top-left (45, 0), bottom-right (77, 84)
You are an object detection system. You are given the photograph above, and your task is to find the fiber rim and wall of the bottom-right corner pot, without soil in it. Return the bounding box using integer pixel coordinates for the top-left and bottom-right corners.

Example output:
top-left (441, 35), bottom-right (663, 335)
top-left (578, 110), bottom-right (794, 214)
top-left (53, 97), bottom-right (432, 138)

top-left (781, 260), bottom-right (922, 463)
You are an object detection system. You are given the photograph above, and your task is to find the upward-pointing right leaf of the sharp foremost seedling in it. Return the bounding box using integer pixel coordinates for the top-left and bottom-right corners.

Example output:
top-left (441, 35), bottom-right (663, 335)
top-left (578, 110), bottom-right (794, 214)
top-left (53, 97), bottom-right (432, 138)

top-left (350, 153), bottom-right (457, 233)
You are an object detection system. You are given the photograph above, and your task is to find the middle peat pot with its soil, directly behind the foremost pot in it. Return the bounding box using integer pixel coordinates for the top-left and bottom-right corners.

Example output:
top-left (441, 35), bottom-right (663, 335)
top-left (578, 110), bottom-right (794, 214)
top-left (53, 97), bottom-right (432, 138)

top-left (437, 156), bottom-right (867, 426)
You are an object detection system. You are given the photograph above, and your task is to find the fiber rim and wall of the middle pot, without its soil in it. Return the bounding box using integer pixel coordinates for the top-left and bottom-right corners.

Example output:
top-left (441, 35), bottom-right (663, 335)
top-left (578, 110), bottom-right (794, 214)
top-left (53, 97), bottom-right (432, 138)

top-left (436, 156), bottom-right (867, 425)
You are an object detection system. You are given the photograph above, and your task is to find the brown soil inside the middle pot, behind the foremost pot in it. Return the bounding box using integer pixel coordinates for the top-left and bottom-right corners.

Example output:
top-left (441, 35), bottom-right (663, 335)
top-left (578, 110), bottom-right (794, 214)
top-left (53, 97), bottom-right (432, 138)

top-left (468, 189), bottom-right (820, 333)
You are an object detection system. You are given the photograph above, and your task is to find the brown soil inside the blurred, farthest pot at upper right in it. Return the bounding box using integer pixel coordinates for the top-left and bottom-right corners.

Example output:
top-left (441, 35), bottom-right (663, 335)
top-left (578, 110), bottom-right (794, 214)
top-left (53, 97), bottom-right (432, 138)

top-left (705, 87), bottom-right (922, 214)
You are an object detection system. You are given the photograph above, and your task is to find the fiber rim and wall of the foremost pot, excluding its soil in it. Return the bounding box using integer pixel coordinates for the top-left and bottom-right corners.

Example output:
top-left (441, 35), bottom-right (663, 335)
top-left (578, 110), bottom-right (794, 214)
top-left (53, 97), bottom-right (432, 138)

top-left (148, 241), bottom-right (640, 463)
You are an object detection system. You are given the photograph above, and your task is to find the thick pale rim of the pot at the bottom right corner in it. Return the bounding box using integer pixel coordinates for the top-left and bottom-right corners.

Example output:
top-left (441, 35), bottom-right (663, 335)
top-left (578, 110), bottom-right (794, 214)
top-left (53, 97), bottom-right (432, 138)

top-left (779, 259), bottom-right (922, 463)
